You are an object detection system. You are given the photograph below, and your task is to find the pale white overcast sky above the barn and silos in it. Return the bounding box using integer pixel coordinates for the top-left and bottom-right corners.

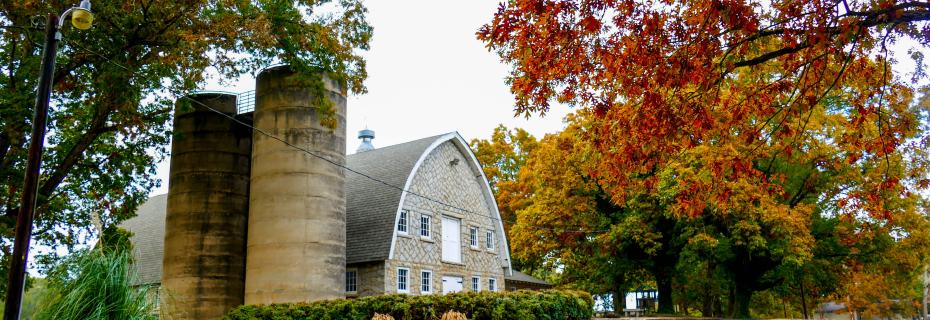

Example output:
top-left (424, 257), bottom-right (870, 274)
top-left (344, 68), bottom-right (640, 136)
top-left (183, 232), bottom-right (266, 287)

top-left (151, 0), bottom-right (571, 195)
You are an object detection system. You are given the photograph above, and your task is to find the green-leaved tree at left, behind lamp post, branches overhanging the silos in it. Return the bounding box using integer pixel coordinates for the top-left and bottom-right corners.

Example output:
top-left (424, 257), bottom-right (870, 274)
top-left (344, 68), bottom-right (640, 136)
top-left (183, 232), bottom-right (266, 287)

top-left (0, 0), bottom-right (371, 292)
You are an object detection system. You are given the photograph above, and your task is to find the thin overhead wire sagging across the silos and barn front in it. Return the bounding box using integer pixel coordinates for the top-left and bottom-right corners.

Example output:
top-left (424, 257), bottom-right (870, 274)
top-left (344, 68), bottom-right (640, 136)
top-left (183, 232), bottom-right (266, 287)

top-left (61, 35), bottom-right (607, 233)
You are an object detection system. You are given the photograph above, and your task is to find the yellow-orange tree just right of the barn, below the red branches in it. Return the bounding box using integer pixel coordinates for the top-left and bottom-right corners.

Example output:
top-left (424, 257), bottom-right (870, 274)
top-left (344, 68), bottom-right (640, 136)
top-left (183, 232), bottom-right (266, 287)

top-left (485, 115), bottom-right (684, 313)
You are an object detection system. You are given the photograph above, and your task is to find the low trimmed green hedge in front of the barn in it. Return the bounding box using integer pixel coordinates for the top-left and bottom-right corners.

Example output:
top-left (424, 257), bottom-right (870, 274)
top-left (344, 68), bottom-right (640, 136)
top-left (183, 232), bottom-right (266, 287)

top-left (223, 290), bottom-right (594, 320)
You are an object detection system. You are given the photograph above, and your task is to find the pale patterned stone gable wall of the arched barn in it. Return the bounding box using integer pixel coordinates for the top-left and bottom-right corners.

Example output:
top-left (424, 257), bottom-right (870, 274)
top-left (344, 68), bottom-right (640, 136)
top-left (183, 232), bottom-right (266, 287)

top-left (384, 141), bottom-right (507, 294)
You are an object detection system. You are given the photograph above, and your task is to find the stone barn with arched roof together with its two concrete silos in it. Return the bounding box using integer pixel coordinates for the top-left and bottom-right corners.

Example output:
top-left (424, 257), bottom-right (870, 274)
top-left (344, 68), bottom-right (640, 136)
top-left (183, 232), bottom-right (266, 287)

top-left (122, 66), bottom-right (548, 319)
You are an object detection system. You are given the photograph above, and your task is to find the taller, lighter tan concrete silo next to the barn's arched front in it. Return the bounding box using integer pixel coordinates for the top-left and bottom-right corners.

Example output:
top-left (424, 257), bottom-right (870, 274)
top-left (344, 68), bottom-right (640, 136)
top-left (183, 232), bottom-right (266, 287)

top-left (245, 66), bottom-right (346, 304)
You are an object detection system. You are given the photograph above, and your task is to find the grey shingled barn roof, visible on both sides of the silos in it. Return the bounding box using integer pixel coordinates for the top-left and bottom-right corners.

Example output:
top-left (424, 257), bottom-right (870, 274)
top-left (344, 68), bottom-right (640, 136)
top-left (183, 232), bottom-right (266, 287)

top-left (121, 135), bottom-right (445, 284)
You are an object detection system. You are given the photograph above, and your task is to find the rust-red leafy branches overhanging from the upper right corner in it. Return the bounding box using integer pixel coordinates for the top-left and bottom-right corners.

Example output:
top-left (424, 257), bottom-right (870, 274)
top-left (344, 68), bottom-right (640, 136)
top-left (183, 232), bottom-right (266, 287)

top-left (478, 0), bottom-right (930, 215)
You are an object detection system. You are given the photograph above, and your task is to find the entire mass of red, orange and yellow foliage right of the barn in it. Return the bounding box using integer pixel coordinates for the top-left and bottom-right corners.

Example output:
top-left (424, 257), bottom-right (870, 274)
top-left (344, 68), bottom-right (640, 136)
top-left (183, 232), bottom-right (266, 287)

top-left (478, 0), bottom-right (930, 317)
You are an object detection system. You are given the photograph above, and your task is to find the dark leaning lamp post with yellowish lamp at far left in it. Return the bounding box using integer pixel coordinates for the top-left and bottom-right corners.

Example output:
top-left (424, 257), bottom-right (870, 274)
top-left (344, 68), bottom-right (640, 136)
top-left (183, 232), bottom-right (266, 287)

top-left (3, 0), bottom-right (94, 320)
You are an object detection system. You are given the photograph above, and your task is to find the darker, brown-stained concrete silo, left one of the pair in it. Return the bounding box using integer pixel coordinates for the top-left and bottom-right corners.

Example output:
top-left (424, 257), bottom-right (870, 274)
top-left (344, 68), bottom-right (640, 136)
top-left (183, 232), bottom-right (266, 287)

top-left (161, 94), bottom-right (252, 320)
